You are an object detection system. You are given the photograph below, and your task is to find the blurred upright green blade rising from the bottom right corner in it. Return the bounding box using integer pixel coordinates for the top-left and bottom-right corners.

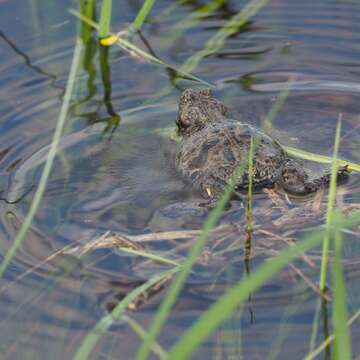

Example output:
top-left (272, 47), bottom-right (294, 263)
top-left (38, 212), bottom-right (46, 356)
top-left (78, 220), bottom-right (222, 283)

top-left (332, 217), bottom-right (352, 360)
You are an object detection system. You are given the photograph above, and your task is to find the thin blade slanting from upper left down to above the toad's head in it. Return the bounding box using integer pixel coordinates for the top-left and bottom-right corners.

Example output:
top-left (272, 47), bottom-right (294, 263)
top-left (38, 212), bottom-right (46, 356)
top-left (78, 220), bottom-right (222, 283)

top-left (69, 9), bottom-right (214, 88)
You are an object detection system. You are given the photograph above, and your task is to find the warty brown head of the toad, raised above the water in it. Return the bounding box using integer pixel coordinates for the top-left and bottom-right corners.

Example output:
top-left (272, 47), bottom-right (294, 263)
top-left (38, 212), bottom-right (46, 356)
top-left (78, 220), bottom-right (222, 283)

top-left (176, 89), bottom-right (226, 135)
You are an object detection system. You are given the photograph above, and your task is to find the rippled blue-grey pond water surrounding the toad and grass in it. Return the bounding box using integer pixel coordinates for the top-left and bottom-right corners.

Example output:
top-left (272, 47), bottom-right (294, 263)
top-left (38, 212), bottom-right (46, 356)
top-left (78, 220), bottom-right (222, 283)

top-left (0, 0), bottom-right (360, 359)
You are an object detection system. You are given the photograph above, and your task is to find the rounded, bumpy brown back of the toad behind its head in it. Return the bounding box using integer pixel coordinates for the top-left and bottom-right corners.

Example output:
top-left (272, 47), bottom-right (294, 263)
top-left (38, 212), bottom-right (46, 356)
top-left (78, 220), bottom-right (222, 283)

top-left (176, 120), bottom-right (284, 188)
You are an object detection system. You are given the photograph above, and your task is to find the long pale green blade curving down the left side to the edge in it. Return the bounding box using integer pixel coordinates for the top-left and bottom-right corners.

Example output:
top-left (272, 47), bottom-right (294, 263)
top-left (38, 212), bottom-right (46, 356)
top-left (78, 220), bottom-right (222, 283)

top-left (0, 39), bottom-right (83, 276)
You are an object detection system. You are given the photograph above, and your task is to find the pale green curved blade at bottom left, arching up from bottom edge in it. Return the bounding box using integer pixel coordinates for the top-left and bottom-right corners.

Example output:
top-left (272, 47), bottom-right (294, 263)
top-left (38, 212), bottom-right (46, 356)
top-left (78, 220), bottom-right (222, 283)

top-left (74, 267), bottom-right (179, 360)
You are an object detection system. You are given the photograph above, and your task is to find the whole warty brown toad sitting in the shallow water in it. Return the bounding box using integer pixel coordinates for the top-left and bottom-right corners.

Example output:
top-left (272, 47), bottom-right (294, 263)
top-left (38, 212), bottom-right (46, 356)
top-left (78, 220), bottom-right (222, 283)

top-left (176, 89), bottom-right (347, 199)
